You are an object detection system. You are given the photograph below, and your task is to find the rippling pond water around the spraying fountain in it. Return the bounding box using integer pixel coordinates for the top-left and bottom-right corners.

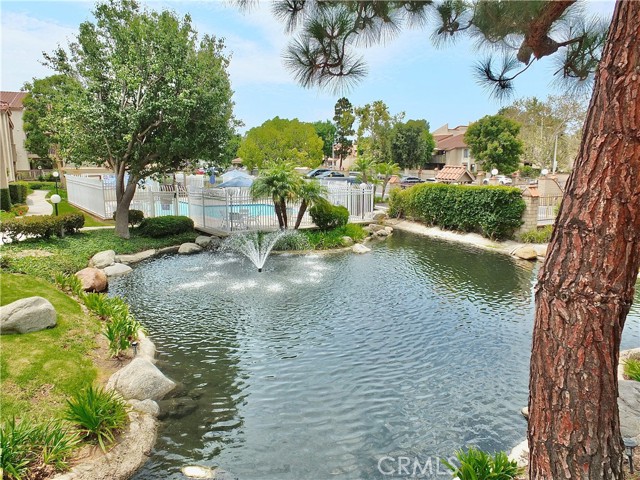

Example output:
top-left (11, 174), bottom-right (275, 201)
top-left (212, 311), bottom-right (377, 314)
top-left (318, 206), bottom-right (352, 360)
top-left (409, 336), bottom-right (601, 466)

top-left (110, 232), bottom-right (640, 480)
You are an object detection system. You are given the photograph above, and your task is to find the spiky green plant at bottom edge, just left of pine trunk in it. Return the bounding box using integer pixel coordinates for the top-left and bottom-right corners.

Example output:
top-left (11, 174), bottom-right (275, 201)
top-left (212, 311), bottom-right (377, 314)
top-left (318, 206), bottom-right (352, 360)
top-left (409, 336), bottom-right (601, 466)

top-left (442, 447), bottom-right (523, 480)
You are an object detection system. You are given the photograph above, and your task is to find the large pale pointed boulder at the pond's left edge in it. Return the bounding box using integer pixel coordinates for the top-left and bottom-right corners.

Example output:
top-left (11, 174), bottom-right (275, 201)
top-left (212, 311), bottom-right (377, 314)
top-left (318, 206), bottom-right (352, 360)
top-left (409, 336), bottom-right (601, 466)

top-left (107, 357), bottom-right (176, 400)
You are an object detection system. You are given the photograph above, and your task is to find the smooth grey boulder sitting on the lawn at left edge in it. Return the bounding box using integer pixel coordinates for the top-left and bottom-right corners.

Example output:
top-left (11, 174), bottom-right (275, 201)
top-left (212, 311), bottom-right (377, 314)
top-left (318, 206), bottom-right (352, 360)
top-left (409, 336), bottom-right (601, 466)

top-left (0, 297), bottom-right (56, 335)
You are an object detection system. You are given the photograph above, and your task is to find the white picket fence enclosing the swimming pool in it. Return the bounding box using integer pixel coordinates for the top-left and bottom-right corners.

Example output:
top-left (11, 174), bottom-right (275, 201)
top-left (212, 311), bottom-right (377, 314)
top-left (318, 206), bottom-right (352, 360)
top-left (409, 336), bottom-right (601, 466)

top-left (65, 175), bottom-right (374, 232)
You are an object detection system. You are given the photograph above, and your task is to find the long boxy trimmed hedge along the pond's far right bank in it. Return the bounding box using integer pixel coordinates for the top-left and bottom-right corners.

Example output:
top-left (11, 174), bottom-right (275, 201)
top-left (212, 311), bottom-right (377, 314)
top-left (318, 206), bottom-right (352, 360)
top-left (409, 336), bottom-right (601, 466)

top-left (389, 183), bottom-right (525, 239)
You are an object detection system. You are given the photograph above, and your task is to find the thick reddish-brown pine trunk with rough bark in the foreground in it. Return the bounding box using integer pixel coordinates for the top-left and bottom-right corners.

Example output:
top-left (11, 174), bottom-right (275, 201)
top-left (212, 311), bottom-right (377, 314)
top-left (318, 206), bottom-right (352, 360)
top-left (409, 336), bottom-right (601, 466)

top-left (529, 1), bottom-right (640, 480)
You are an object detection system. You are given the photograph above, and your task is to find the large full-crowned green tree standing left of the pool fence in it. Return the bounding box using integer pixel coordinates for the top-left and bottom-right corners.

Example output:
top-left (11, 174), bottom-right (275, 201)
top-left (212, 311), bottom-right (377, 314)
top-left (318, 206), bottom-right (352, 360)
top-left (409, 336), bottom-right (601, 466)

top-left (45, 0), bottom-right (235, 238)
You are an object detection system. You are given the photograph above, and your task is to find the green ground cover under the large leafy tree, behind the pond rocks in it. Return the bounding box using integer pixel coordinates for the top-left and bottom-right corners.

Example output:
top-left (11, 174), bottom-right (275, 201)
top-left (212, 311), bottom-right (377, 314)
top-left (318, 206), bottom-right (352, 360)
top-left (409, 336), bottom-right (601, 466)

top-left (0, 229), bottom-right (196, 281)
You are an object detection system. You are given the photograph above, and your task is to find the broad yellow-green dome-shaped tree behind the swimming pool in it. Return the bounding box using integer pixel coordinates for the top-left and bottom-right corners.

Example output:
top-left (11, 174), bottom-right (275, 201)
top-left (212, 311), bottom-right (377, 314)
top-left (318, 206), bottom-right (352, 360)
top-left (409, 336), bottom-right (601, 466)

top-left (238, 117), bottom-right (322, 170)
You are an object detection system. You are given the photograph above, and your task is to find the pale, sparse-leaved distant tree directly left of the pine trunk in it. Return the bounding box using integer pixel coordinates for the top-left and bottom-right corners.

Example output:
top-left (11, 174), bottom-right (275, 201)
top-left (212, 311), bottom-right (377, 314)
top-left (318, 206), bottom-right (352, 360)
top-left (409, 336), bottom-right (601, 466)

top-left (498, 92), bottom-right (587, 171)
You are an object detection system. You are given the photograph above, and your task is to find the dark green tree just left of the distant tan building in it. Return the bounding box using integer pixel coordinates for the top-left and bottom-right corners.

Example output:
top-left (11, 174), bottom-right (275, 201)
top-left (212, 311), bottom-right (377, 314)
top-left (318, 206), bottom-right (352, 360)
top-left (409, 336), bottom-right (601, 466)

top-left (391, 120), bottom-right (436, 168)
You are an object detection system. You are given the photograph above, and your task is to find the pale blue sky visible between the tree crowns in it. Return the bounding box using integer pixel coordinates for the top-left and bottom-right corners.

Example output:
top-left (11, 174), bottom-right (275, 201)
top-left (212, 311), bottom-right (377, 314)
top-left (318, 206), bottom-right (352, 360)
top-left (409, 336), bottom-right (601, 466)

top-left (0, 0), bottom-right (614, 131)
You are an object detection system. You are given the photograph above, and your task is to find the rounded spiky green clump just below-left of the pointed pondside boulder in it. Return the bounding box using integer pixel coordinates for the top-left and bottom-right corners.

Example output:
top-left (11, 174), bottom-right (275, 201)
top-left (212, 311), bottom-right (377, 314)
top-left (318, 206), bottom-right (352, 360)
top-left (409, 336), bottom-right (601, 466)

top-left (65, 386), bottom-right (127, 452)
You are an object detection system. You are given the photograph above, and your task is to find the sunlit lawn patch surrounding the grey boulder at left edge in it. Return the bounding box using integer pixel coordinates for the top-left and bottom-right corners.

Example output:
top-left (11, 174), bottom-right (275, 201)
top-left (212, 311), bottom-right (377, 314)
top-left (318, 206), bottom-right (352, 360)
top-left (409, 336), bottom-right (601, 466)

top-left (0, 273), bottom-right (100, 421)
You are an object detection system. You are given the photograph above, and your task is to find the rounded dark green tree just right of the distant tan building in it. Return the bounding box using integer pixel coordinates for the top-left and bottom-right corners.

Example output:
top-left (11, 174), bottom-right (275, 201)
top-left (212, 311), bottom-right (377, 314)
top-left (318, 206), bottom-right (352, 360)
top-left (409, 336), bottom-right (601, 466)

top-left (464, 115), bottom-right (522, 173)
